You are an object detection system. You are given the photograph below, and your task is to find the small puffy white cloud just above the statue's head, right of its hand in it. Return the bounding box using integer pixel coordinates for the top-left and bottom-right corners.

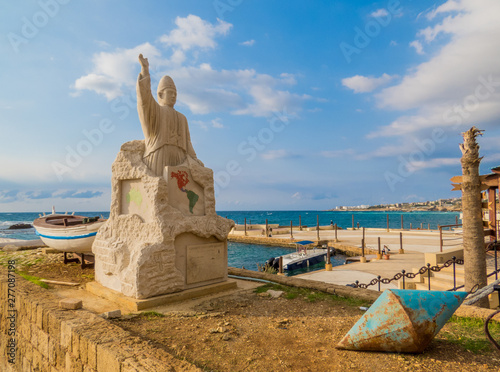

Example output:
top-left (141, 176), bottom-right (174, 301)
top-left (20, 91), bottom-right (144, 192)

top-left (160, 14), bottom-right (233, 50)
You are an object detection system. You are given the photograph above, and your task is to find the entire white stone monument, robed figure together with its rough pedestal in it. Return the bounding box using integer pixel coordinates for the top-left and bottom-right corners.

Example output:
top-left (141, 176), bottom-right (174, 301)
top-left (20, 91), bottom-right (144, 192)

top-left (92, 54), bottom-right (234, 300)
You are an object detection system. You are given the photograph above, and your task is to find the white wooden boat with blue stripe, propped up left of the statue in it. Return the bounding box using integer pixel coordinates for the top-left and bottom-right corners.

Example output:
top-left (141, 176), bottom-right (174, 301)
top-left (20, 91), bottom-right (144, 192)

top-left (33, 208), bottom-right (106, 253)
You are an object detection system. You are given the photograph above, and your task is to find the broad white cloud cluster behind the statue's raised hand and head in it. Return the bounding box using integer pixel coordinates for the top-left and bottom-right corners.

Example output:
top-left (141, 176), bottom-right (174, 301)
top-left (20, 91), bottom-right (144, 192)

top-left (73, 15), bottom-right (312, 116)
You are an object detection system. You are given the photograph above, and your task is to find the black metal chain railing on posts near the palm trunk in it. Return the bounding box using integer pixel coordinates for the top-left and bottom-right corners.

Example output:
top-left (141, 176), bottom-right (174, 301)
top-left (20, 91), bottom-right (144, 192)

top-left (349, 241), bottom-right (500, 292)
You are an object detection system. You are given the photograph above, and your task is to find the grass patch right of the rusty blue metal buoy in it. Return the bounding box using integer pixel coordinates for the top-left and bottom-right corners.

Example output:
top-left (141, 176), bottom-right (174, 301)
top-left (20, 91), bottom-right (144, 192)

top-left (439, 316), bottom-right (500, 354)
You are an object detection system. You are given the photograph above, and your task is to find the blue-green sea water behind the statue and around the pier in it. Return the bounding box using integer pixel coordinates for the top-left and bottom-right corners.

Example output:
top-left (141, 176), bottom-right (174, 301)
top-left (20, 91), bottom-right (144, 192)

top-left (0, 211), bottom-right (460, 271)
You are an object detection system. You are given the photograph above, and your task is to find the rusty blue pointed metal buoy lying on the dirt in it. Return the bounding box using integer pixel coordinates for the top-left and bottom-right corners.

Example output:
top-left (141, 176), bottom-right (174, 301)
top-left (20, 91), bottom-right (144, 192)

top-left (337, 289), bottom-right (468, 353)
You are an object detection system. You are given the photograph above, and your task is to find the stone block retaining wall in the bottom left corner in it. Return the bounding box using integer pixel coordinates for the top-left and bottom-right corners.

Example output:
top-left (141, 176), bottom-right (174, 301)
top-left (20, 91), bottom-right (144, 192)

top-left (0, 268), bottom-right (201, 372)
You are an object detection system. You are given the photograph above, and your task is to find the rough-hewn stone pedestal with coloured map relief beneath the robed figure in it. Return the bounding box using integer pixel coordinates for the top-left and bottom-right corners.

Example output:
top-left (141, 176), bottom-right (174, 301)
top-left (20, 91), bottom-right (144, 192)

top-left (92, 141), bottom-right (234, 299)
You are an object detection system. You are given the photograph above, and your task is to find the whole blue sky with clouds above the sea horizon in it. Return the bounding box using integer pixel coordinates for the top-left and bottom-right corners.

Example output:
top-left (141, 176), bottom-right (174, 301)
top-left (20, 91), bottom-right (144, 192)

top-left (0, 0), bottom-right (500, 212)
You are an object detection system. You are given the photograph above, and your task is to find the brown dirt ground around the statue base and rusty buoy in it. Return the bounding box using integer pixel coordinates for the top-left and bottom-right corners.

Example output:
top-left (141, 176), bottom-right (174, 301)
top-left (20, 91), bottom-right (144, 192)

top-left (0, 250), bottom-right (500, 372)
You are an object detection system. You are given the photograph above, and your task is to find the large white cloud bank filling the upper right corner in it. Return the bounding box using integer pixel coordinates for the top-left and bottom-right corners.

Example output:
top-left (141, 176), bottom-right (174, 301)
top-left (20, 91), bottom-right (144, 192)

top-left (371, 0), bottom-right (500, 140)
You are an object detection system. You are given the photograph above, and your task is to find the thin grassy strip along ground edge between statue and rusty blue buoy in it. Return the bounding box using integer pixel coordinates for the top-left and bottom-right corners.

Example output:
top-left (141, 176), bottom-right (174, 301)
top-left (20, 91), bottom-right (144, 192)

top-left (255, 283), bottom-right (370, 307)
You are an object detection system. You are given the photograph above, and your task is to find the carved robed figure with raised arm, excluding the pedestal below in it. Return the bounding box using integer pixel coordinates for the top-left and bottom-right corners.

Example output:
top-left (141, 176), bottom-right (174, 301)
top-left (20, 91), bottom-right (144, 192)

top-left (137, 54), bottom-right (203, 177)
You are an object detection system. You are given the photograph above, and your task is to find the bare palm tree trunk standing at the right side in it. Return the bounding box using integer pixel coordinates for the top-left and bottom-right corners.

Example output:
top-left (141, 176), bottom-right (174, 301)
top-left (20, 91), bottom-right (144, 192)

top-left (460, 127), bottom-right (489, 307)
